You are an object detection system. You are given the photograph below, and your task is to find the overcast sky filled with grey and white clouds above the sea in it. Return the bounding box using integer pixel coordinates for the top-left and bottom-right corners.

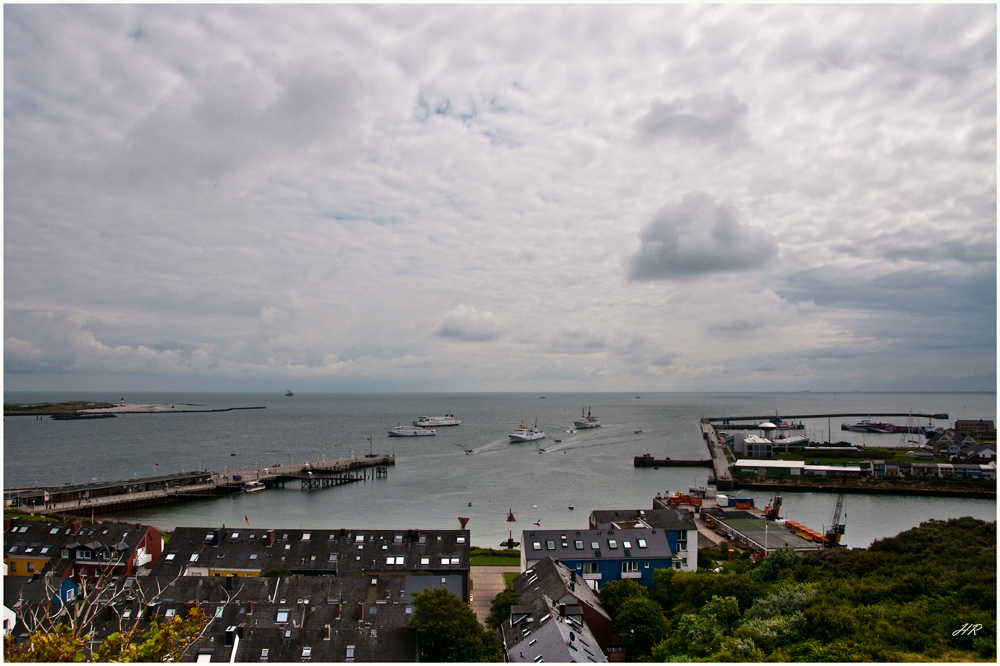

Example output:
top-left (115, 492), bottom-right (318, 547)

top-left (3, 5), bottom-right (997, 391)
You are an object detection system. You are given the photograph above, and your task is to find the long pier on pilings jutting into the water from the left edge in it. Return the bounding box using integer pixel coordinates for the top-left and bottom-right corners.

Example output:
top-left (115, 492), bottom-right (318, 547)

top-left (4, 454), bottom-right (396, 515)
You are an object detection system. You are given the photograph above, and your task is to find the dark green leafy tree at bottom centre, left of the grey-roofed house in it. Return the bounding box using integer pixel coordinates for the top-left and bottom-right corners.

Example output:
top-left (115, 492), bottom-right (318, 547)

top-left (410, 587), bottom-right (501, 662)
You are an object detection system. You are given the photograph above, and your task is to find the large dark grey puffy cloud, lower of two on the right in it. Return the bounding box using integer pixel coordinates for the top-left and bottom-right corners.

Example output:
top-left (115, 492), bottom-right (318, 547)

top-left (628, 192), bottom-right (778, 281)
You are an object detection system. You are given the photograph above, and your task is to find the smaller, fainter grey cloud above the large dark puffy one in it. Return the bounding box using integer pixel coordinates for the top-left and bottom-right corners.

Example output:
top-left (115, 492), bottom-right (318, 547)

top-left (635, 94), bottom-right (750, 149)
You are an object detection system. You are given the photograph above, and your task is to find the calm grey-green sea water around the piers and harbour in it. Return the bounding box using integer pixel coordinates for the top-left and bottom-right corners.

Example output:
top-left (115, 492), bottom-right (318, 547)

top-left (4, 392), bottom-right (996, 546)
